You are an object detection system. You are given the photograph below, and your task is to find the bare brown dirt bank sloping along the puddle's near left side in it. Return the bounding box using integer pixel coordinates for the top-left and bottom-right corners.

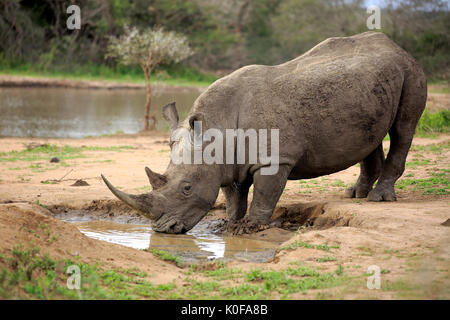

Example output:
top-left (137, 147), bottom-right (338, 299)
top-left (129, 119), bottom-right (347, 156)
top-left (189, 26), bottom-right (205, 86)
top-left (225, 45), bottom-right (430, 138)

top-left (0, 203), bottom-right (185, 284)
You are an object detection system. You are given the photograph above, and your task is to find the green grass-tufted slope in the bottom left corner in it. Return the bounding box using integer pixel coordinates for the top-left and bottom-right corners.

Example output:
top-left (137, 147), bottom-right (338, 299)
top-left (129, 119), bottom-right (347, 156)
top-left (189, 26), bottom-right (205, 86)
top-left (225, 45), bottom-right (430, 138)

top-left (0, 245), bottom-right (183, 300)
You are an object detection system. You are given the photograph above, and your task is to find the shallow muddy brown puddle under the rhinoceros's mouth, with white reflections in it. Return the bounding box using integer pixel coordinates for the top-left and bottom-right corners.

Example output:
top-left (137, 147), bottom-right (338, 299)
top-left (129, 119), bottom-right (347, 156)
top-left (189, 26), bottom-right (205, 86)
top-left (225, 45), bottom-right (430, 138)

top-left (64, 218), bottom-right (279, 262)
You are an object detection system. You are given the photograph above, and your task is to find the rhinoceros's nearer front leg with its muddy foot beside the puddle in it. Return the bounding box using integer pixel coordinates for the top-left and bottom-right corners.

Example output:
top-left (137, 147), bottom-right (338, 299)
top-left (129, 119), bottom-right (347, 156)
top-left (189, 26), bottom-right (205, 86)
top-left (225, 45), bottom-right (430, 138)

top-left (228, 166), bottom-right (291, 234)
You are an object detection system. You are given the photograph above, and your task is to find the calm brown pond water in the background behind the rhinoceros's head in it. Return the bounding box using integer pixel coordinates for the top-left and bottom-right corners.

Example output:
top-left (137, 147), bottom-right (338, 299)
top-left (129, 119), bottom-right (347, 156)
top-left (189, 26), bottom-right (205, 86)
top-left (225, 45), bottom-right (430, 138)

top-left (0, 87), bottom-right (201, 138)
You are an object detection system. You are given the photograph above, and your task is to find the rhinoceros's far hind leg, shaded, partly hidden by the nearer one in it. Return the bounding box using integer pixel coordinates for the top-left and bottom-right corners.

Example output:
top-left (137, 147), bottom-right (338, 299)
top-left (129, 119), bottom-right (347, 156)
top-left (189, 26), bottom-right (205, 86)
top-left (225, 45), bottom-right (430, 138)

top-left (344, 144), bottom-right (384, 198)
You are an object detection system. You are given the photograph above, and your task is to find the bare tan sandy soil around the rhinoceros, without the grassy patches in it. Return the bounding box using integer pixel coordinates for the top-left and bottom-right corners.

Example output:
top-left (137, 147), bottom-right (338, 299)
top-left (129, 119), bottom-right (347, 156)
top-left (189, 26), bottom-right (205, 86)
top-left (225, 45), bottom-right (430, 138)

top-left (0, 133), bottom-right (450, 299)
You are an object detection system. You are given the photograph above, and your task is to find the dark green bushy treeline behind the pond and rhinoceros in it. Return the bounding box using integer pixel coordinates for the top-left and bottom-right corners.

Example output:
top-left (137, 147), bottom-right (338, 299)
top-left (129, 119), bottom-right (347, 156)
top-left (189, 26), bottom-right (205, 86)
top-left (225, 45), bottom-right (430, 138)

top-left (0, 0), bottom-right (450, 79)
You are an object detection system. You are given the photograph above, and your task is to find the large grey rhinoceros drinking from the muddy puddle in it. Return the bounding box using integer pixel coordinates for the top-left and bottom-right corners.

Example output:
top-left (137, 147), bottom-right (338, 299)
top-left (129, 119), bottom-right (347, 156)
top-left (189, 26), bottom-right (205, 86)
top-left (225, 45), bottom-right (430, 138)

top-left (101, 32), bottom-right (427, 233)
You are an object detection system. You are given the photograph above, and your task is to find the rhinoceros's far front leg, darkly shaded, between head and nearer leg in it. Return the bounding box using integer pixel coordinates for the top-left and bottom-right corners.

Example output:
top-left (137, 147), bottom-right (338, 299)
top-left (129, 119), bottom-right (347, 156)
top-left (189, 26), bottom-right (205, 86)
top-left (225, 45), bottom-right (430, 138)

top-left (222, 181), bottom-right (251, 221)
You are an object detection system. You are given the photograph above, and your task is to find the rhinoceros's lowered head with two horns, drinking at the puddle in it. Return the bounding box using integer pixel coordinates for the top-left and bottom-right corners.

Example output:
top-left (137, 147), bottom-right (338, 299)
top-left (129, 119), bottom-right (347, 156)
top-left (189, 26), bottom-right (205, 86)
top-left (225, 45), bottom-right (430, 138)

top-left (102, 103), bottom-right (220, 233)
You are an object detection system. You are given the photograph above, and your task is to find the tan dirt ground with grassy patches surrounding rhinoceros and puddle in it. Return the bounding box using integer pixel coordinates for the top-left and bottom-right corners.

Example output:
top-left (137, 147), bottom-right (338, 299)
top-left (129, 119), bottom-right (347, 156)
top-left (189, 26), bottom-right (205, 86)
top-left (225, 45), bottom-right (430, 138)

top-left (0, 133), bottom-right (450, 299)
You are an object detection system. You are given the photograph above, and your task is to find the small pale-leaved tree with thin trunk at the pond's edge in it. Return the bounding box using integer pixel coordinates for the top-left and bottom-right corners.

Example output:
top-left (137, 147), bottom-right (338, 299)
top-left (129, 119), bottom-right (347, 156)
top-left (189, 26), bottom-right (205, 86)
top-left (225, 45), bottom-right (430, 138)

top-left (106, 27), bottom-right (193, 130)
